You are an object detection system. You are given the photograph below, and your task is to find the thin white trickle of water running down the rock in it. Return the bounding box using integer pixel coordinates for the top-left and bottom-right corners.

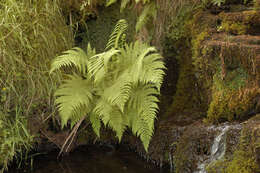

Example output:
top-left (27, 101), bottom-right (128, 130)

top-left (194, 125), bottom-right (230, 173)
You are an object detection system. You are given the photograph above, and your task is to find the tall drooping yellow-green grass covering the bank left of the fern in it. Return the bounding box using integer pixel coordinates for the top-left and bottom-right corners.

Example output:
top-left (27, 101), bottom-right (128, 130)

top-left (0, 0), bottom-right (74, 170)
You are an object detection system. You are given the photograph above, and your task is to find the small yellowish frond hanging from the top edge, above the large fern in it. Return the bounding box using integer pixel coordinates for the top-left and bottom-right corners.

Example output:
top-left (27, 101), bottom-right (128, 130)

top-left (135, 2), bottom-right (157, 32)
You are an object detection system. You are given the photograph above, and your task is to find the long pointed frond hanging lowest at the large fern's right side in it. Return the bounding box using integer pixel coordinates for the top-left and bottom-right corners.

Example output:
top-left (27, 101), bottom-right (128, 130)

top-left (127, 84), bottom-right (159, 150)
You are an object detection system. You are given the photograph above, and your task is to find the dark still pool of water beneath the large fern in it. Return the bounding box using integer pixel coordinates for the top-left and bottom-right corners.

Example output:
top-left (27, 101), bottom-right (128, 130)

top-left (8, 146), bottom-right (169, 173)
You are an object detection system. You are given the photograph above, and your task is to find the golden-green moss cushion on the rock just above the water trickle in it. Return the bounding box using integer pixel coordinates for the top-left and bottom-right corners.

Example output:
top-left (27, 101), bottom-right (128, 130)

top-left (206, 82), bottom-right (259, 123)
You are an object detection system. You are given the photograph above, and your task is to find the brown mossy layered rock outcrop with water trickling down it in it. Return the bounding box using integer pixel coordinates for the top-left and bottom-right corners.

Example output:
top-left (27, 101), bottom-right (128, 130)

top-left (124, 1), bottom-right (260, 173)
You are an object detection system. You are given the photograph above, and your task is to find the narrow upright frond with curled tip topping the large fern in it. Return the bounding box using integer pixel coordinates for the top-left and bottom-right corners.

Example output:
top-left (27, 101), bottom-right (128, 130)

top-left (105, 19), bottom-right (128, 50)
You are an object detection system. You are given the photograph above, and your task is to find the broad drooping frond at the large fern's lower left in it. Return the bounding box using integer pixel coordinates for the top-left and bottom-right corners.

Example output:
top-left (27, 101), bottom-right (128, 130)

top-left (55, 74), bottom-right (93, 127)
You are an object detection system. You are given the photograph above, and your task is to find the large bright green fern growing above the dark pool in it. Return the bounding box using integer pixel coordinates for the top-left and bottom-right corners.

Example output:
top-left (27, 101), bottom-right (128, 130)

top-left (50, 20), bottom-right (165, 151)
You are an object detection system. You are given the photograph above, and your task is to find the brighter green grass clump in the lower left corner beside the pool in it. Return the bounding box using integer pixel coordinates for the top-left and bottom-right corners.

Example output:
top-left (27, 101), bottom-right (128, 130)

top-left (0, 109), bottom-right (33, 172)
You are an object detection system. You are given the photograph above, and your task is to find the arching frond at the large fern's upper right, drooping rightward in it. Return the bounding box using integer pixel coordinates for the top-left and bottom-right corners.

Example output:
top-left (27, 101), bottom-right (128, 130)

top-left (120, 41), bottom-right (165, 89)
